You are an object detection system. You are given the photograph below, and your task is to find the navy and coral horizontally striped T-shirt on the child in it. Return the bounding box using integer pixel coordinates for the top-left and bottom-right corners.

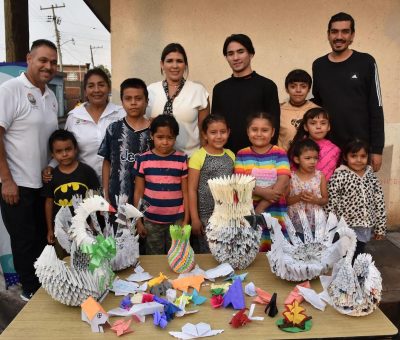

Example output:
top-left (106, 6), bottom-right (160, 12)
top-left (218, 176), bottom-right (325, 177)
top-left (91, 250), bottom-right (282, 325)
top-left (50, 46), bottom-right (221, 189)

top-left (135, 151), bottom-right (188, 224)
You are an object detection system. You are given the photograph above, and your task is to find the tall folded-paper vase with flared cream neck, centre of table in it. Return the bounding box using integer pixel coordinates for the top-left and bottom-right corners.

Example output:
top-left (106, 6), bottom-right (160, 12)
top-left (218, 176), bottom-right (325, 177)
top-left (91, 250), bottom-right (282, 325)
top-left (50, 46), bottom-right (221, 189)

top-left (206, 175), bottom-right (261, 269)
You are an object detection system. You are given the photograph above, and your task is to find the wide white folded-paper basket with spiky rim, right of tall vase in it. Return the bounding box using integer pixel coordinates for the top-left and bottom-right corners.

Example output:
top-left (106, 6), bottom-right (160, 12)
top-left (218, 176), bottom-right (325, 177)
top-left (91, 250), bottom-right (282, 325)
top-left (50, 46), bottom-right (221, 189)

top-left (263, 210), bottom-right (357, 281)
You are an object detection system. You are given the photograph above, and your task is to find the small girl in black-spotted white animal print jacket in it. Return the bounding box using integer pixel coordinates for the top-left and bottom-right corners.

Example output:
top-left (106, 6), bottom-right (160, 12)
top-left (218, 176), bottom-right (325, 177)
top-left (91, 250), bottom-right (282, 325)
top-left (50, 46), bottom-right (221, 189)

top-left (326, 139), bottom-right (386, 258)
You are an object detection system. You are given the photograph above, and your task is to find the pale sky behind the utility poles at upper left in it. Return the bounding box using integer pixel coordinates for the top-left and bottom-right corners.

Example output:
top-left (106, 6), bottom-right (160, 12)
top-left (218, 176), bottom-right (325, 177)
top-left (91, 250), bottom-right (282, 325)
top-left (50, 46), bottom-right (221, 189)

top-left (0, 0), bottom-right (111, 69)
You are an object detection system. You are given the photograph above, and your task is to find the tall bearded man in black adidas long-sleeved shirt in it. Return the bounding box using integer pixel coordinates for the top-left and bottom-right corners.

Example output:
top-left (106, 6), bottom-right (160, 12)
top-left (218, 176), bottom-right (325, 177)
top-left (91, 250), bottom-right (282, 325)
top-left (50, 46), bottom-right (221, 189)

top-left (313, 13), bottom-right (385, 171)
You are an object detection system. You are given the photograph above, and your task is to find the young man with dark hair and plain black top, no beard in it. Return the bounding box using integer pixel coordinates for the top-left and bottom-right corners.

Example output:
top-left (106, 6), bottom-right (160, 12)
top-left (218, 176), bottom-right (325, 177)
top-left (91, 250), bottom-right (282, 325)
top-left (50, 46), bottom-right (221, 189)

top-left (211, 34), bottom-right (280, 153)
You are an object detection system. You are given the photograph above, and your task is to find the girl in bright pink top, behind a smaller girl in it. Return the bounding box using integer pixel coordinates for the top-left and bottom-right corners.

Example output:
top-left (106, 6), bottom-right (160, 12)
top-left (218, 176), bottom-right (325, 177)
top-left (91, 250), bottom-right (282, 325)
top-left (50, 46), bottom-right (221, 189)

top-left (288, 107), bottom-right (340, 180)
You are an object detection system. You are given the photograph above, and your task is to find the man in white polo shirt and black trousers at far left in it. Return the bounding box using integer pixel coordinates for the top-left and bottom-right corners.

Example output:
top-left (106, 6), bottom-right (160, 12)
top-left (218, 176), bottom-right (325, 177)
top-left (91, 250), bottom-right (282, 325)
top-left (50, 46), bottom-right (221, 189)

top-left (0, 39), bottom-right (57, 301)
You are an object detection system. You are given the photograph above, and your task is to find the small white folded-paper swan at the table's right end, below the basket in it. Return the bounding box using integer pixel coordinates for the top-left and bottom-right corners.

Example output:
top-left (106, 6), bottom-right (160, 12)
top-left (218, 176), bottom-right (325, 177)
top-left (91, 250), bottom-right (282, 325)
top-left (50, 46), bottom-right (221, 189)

top-left (321, 254), bottom-right (382, 316)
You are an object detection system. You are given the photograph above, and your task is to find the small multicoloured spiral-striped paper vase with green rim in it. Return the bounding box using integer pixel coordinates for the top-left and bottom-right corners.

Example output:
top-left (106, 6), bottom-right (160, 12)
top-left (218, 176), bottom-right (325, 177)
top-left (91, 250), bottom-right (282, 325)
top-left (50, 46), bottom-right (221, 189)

top-left (167, 225), bottom-right (195, 273)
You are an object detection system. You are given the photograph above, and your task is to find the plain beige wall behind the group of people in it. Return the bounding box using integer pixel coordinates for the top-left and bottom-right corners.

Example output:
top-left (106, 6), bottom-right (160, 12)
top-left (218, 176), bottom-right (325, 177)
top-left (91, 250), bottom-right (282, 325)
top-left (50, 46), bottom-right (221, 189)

top-left (111, 0), bottom-right (400, 225)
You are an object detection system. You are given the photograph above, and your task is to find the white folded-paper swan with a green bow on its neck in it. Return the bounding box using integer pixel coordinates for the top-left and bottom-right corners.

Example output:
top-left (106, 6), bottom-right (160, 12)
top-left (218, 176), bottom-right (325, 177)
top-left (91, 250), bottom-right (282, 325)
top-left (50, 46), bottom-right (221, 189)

top-left (34, 196), bottom-right (116, 306)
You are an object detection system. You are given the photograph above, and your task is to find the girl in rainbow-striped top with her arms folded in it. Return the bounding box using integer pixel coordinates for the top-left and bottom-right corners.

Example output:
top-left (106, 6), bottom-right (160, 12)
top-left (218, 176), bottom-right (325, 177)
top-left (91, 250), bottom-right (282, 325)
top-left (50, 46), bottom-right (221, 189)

top-left (235, 112), bottom-right (290, 251)
